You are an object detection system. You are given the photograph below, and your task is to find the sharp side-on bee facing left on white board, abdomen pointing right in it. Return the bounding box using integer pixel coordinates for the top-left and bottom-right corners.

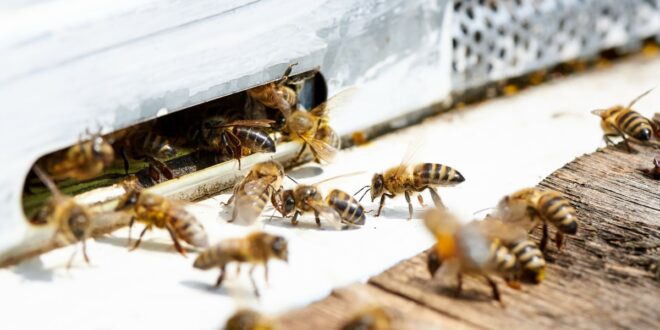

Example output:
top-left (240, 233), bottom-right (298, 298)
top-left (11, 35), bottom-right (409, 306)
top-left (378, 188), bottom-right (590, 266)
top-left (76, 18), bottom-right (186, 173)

top-left (356, 163), bottom-right (465, 220)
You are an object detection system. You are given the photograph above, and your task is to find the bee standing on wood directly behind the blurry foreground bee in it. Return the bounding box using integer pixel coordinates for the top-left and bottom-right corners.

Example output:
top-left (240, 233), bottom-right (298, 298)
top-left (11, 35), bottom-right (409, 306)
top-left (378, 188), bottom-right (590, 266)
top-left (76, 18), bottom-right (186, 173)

top-left (495, 188), bottom-right (578, 251)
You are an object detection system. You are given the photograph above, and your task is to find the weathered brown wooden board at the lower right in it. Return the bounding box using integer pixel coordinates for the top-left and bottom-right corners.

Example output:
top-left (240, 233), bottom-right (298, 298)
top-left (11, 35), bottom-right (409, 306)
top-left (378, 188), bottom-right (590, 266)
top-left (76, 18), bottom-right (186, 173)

top-left (280, 147), bottom-right (660, 329)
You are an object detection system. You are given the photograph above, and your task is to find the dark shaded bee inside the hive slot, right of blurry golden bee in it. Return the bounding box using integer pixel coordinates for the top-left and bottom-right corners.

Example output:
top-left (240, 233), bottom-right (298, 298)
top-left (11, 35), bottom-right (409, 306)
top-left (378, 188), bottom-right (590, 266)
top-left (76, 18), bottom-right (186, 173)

top-left (115, 125), bottom-right (176, 181)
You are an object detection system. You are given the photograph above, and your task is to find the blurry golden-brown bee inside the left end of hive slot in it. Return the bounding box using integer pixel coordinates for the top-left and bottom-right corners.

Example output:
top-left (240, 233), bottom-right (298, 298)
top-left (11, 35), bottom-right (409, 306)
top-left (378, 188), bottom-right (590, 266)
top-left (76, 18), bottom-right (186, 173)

top-left (38, 134), bottom-right (115, 181)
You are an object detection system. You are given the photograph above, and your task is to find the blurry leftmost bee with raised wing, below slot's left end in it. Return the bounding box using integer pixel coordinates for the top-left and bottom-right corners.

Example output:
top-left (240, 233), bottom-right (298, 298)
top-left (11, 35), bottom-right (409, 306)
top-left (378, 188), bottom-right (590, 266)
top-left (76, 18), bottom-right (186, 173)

top-left (32, 165), bottom-right (92, 268)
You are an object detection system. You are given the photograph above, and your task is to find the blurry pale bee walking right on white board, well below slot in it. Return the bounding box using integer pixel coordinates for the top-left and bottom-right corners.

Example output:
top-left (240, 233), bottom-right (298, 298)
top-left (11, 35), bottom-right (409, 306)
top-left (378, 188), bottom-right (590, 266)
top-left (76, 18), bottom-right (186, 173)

top-left (193, 232), bottom-right (289, 297)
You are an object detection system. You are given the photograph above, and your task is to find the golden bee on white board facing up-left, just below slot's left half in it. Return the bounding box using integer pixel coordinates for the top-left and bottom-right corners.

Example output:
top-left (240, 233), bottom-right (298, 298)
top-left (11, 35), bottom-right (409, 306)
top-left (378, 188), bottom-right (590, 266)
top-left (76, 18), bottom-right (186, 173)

top-left (116, 187), bottom-right (208, 256)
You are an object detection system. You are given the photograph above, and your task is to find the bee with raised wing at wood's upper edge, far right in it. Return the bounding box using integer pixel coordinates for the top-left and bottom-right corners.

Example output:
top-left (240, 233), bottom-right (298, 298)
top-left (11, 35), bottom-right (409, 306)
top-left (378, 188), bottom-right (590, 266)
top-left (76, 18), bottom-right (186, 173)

top-left (591, 90), bottom-right (658, 152)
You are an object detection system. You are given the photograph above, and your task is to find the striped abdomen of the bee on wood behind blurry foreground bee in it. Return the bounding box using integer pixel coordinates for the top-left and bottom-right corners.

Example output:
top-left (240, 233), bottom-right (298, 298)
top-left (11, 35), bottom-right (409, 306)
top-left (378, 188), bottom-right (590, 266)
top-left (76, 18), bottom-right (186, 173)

top-left (538, 192), bottom-right (577, 235)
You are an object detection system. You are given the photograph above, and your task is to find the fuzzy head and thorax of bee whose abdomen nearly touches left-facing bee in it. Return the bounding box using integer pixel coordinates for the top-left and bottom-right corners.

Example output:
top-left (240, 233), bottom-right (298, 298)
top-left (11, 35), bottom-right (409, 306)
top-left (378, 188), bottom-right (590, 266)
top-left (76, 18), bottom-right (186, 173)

top-left (272, 184), bottom-right (342, 229)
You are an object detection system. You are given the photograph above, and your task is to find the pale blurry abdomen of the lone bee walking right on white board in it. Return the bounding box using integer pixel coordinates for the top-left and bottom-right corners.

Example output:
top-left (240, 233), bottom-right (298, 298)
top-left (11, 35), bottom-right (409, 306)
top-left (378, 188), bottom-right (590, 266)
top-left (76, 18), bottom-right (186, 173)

top-left (193, 238), bottom-right (250, 269)
